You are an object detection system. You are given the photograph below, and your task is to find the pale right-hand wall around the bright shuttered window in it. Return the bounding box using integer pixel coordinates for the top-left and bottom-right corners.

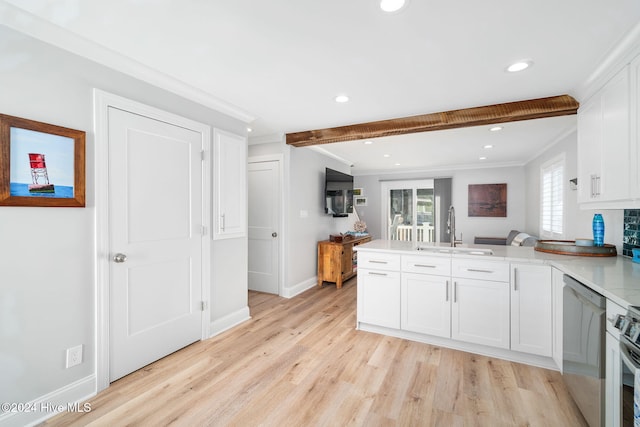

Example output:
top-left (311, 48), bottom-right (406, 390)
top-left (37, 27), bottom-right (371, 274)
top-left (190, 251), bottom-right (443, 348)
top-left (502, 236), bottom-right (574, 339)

top-left (525, 131), bottom-right (624, 254)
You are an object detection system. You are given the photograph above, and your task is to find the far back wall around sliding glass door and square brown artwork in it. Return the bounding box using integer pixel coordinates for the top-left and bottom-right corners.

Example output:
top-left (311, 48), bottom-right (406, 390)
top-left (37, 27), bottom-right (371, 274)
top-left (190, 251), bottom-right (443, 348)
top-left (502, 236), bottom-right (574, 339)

top-left (354, 167), bottom-right (527, 243)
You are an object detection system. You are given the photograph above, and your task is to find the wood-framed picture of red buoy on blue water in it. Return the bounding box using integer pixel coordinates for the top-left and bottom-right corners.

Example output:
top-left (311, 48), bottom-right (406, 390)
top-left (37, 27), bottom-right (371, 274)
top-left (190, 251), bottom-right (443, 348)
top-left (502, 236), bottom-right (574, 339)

top-left (0, 114), bottom-right (85, 207)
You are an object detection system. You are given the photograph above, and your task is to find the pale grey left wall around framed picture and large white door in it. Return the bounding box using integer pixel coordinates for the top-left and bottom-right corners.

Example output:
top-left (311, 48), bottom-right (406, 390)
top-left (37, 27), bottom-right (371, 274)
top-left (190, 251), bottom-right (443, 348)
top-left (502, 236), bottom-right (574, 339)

top-left (0, 26), bottom-right (247, 425)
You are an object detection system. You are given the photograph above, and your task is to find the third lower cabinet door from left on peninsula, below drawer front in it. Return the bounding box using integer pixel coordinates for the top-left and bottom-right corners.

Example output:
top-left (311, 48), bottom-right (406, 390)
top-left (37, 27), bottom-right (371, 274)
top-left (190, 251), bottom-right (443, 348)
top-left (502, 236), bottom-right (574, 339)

top-left (451, 277), bottom-right (509, 348)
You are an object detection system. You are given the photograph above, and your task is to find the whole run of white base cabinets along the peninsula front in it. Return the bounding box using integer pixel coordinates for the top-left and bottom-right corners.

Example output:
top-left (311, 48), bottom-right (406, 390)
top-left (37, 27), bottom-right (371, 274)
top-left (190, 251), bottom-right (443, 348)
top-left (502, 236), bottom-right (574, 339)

top-left (357, 251), bottom-right (562, 361)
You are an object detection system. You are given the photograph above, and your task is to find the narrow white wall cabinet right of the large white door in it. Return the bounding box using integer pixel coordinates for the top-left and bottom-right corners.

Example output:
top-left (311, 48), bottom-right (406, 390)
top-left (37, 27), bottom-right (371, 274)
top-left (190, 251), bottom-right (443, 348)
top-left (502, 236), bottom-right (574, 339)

top-left (213, 129), bottom-right (247, 239)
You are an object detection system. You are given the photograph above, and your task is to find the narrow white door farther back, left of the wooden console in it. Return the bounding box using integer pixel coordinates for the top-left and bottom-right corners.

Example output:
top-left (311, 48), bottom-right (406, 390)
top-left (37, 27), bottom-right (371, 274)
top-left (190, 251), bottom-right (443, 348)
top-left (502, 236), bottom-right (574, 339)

top-left (248, 161), bottom-right (280, 294)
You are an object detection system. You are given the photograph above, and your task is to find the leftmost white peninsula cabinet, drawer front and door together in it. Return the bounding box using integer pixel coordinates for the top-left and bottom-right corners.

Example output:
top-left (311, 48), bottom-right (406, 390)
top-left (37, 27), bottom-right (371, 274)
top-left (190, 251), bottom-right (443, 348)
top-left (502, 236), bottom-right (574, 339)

top-left (357, 252), bottom-right (400, 329)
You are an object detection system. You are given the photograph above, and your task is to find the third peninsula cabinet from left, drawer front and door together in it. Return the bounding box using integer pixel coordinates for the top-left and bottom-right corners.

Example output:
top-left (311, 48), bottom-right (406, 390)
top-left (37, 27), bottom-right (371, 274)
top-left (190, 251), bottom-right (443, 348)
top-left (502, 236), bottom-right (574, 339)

top-left (451, 259), bottom-right (509, 348)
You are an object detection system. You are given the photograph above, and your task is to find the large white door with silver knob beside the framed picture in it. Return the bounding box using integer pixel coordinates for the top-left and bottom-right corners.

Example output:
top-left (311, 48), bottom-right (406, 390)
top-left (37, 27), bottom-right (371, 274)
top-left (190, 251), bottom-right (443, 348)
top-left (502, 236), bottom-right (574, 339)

top-left (108, 107), bottom-right (203, 381)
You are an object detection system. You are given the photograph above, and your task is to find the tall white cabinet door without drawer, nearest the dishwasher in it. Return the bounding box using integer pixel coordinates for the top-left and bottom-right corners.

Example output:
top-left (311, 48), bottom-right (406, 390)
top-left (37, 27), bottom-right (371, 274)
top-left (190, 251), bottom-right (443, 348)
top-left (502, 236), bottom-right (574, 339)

top-left (511, 263), bottom-right (553, 357)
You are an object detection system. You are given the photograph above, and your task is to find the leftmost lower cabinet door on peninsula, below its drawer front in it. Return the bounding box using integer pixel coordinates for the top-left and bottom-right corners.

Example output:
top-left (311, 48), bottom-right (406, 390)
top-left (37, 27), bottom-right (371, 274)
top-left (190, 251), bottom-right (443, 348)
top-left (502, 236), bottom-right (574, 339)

top-left (357, 268), bottom-right (400, 329)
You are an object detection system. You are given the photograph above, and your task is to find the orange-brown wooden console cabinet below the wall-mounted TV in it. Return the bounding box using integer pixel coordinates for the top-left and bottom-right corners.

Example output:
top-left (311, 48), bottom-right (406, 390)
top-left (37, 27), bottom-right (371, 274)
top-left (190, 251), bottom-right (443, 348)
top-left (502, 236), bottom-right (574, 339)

top-left (318, 236), bottom-right (371, 289)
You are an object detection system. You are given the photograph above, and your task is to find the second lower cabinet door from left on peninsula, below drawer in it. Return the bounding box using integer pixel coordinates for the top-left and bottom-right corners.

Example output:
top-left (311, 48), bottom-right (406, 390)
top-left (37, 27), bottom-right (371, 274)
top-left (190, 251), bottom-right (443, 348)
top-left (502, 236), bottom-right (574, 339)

top-left (400, 272), bottom-right (451, 338)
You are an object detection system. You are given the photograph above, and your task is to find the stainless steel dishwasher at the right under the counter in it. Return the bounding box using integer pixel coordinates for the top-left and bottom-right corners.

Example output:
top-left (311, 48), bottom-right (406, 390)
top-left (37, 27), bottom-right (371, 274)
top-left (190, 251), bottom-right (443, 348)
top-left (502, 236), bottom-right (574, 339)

top-left (562, 274), bottom-right (606, 427)
